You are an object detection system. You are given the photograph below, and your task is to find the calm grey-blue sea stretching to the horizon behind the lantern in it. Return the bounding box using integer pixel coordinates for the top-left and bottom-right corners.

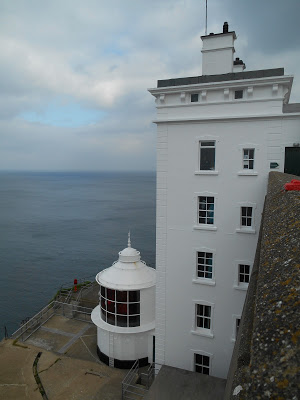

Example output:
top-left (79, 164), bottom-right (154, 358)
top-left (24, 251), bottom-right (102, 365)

top-left (0, 172), bottom-right (156, 339)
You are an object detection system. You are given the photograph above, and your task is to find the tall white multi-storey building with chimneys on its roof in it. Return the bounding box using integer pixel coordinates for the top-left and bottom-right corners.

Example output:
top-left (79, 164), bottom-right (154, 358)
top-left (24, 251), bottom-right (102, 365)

top-left (149, 23), bottom-right (300, 378)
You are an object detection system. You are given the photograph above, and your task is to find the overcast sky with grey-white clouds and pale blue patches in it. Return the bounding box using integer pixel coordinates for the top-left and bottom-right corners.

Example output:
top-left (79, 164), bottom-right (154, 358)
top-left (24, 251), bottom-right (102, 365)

top-left (0, 0), bottom-right (300, 171)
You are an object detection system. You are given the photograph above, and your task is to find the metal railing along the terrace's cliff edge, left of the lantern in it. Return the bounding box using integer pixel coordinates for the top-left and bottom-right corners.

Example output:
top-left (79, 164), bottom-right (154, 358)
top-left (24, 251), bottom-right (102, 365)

top-left (11, 300), bottom-right (92, 342)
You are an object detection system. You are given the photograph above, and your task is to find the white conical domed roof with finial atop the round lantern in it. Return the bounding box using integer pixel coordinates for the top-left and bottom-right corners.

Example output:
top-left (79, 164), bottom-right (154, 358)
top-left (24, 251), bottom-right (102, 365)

top-left (96, 234), bottom-right (156, 290)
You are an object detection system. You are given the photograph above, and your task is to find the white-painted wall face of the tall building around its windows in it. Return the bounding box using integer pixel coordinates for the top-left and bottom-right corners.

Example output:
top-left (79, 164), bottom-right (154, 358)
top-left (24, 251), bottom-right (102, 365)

top-left (156, 79), bottom-right (300, 378)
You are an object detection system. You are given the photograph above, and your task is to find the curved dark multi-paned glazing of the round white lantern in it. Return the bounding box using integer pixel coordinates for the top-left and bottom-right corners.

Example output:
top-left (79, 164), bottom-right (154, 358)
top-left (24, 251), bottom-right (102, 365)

top-left (100, 286), bottom-right (140, 327)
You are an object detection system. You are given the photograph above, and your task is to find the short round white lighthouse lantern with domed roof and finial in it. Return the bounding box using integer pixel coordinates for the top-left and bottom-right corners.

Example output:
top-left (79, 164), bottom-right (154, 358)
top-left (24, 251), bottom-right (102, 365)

top-left (91, 237), bottom-right (156, 368)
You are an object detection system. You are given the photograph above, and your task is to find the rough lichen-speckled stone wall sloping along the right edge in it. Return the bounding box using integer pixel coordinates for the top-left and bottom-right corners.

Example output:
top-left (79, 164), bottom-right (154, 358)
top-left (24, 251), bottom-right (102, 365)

top-left (225, 172), bottom-right (300, 400)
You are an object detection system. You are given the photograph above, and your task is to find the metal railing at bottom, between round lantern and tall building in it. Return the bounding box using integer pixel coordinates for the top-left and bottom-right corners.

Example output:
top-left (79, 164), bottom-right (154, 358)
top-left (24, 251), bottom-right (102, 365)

top-left (122, 360), bottom-right (161, 400)
